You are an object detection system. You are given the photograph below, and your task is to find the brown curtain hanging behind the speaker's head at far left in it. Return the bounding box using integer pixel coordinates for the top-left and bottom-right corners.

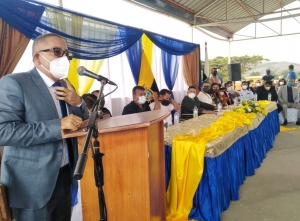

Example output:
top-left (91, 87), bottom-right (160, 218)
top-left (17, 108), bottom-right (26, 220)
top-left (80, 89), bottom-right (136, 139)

top-left (0, 18), bottom-right (30, 78)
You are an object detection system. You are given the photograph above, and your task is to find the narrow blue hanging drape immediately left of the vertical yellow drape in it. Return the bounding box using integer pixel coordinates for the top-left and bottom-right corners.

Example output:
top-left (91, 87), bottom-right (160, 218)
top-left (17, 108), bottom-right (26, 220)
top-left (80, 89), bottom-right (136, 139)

top-left (126, 39), bottom-right (142, 85)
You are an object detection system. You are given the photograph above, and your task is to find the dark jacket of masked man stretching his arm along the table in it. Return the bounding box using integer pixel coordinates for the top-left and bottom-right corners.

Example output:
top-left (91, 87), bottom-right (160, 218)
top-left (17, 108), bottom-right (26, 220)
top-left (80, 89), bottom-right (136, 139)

top-left (181, 96), bottom-right (215, 119)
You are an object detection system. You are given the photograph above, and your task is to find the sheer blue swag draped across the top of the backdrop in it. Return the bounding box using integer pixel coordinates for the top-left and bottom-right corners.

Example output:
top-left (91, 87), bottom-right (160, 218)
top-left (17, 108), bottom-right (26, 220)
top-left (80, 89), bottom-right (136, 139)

top-left (0, 0), bottom-right (197, 60)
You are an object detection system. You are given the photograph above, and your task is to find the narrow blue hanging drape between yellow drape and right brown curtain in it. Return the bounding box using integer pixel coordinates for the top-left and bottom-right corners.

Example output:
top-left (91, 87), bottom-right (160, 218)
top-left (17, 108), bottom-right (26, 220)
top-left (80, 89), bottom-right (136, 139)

top-left (161, 50), bottom-right (179, 95)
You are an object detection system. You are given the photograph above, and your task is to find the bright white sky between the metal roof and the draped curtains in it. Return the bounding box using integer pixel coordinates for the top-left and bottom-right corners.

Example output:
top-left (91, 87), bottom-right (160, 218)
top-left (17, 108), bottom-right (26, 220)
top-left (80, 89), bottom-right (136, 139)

top-left (15, 0), bottom-right (300, 71)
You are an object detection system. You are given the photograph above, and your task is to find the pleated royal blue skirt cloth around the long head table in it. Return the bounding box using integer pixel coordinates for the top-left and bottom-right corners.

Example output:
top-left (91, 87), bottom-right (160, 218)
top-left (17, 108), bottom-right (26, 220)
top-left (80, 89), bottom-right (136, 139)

top-left (165, 110), bottom-right (279, 221)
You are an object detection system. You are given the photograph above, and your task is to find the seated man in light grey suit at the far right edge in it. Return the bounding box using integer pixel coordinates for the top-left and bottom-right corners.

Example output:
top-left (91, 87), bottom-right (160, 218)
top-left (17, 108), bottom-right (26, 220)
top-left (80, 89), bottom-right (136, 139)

top-left (278, 78), bottom-right (300, 125)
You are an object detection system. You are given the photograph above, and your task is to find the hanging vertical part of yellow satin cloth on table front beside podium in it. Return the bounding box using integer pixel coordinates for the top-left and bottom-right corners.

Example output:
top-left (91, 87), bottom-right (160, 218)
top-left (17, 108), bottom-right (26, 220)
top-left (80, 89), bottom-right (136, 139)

top-left (167, 135), bottom-right (207, 221)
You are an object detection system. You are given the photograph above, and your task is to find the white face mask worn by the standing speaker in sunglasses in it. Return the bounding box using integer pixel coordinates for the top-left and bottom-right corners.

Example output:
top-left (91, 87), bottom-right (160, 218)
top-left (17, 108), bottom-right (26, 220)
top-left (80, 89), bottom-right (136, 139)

top-left (40, 54), bottom-right (70, 79)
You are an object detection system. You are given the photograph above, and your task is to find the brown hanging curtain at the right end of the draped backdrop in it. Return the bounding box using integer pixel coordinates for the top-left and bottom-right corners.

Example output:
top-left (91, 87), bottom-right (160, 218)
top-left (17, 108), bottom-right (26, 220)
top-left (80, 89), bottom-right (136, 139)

top-left (182, 47), bottom-right (200, 88)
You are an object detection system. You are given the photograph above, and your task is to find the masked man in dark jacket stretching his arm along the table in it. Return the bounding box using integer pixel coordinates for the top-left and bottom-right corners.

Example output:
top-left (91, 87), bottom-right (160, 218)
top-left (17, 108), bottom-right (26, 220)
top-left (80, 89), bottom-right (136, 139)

top-left (181, 86), bottom-right (216, 119)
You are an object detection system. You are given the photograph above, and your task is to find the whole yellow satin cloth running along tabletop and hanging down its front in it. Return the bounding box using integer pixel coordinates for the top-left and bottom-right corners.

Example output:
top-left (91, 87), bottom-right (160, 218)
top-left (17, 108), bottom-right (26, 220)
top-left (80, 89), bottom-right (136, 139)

top-left (167, 101), bottom-right (270, 221)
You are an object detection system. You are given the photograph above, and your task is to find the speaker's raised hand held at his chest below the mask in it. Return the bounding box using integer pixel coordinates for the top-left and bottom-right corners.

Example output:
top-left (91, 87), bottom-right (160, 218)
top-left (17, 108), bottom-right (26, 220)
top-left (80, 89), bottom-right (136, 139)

top-left (55, 79), bottom-right (82, 106)
